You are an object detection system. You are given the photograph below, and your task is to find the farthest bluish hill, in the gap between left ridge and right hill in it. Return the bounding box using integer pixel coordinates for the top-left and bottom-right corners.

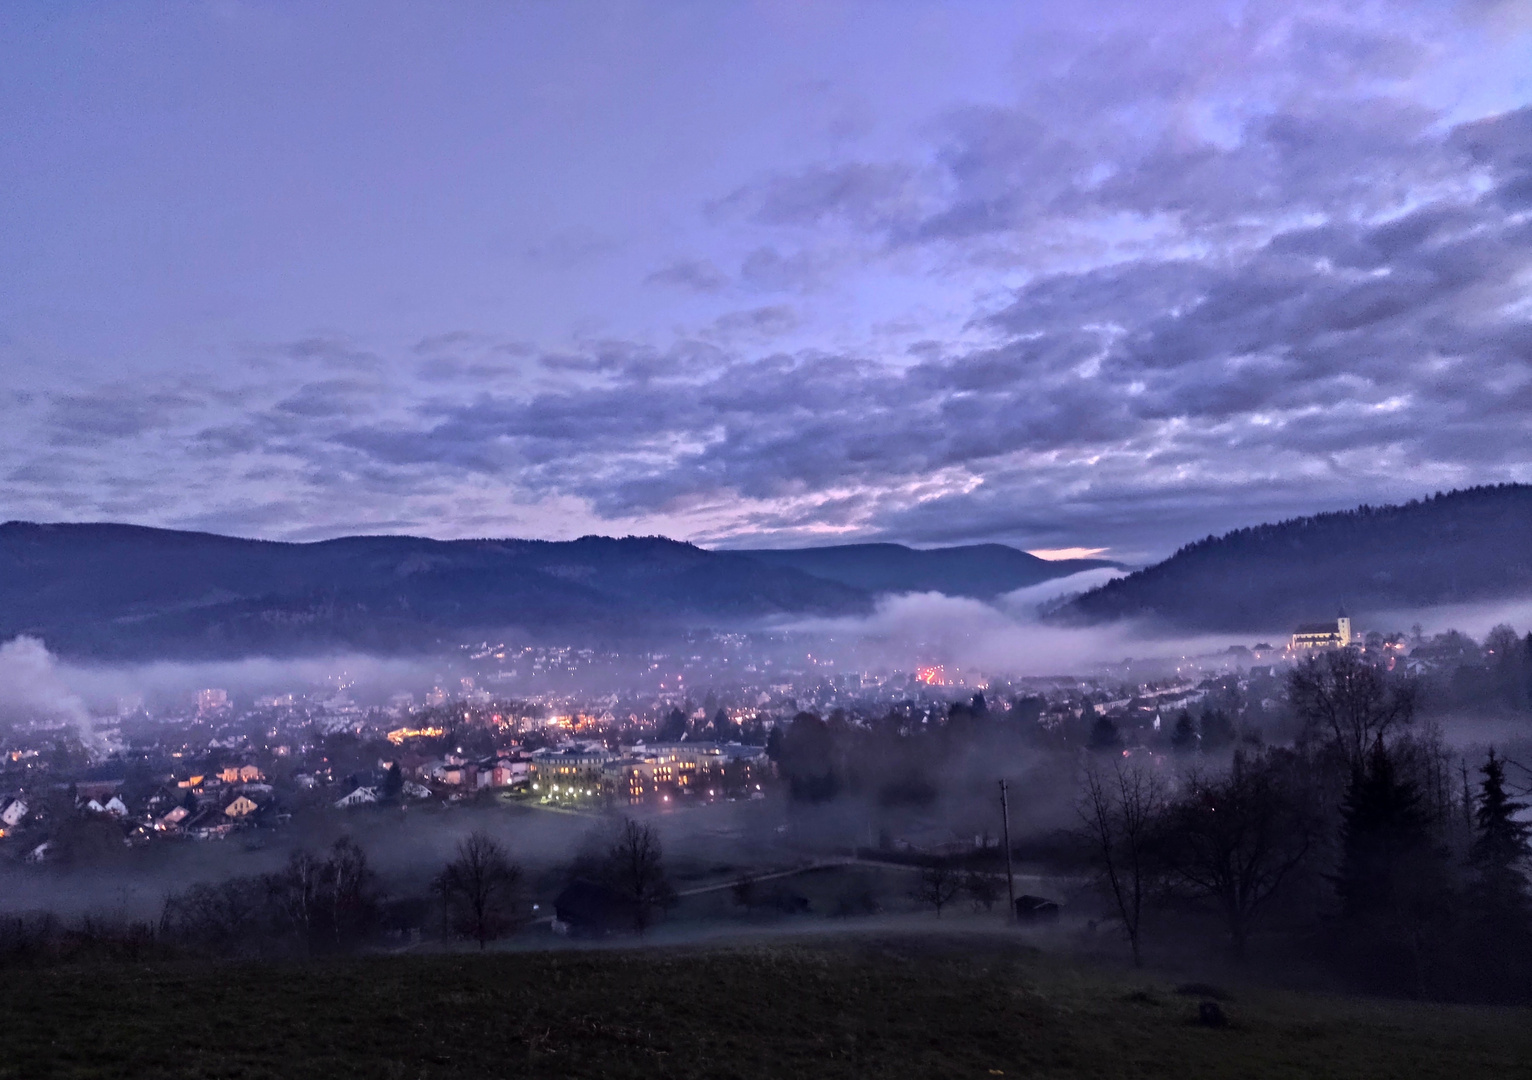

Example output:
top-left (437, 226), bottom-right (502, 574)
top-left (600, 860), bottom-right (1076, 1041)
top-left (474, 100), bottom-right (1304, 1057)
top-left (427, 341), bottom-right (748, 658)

top-left (734, 544), bottom-right (1118, 599)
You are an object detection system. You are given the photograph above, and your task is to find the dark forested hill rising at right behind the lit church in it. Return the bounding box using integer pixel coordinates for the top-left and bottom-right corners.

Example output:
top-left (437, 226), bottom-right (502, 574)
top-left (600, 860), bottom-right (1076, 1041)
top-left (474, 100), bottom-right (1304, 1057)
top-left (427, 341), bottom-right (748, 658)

top-left (1057, 484), bottom-right (1532, 630)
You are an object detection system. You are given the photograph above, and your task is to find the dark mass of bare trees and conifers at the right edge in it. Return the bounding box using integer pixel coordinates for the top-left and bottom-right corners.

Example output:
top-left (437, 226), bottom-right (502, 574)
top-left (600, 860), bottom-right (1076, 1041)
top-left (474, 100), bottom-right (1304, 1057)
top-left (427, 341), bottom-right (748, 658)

top-left (1079, 651), bottom-right (1532, 1000)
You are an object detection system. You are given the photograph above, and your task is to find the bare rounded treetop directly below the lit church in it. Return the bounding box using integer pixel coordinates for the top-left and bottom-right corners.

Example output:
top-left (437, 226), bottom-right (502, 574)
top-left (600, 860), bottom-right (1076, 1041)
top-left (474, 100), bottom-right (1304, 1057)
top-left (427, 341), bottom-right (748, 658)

top-left (1287, 650), bottom-right (1416, 771)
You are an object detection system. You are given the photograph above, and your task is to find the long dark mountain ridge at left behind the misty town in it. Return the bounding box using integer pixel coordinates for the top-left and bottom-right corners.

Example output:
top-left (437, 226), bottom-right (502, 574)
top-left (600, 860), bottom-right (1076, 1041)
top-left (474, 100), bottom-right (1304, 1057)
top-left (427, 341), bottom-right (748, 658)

top-left (0, 522), bottom-right (870, 657)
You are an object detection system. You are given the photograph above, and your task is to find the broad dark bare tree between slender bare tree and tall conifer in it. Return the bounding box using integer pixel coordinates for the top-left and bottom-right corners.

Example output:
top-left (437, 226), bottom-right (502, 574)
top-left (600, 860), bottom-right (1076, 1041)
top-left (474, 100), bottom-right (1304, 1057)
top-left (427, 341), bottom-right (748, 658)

top-left (1161, 751), bottom-right (1318, 959)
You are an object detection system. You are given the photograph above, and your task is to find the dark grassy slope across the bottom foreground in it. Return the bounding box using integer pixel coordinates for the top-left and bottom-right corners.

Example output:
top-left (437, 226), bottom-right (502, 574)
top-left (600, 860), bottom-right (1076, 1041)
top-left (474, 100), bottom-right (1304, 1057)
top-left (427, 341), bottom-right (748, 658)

top-left (0, 938), bottom-right (1532, 1080)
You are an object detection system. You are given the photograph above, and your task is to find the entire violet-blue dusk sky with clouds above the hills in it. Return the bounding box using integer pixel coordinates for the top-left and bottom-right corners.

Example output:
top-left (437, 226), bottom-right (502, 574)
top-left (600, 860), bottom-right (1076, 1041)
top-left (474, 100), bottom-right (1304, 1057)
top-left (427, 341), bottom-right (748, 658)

top-left (0, 0), bottom-right (1532, 561)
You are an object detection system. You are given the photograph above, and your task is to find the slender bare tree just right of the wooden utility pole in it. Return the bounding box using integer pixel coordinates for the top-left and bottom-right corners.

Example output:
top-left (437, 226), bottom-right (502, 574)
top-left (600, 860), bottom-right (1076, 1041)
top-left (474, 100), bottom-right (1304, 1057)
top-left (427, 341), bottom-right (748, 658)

top-left (1079, 760), bottom-right (1166, 967)
